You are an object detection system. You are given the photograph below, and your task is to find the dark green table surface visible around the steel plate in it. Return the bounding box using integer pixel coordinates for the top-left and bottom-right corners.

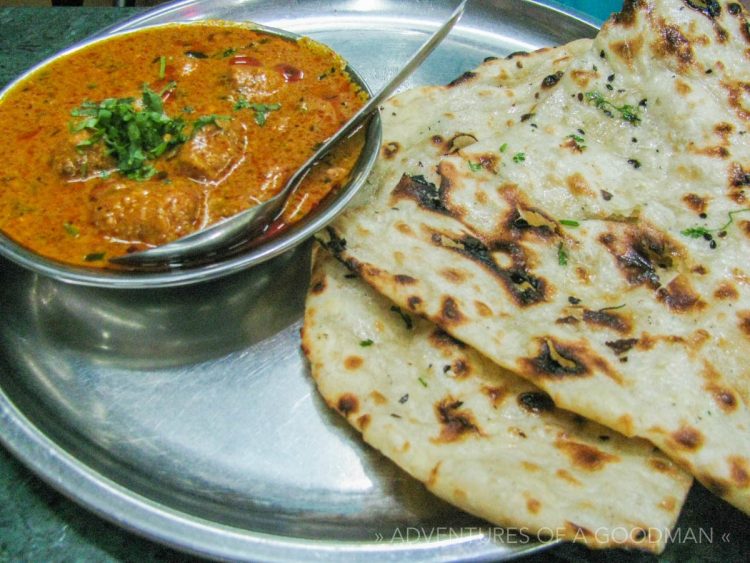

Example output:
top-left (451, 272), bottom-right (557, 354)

top-left (0, 0), bottom-right (750, 563)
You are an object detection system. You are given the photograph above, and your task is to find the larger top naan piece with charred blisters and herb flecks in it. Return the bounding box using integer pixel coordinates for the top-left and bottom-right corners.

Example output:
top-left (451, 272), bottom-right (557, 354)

top-left (322, 0), bottom-right (750, 513)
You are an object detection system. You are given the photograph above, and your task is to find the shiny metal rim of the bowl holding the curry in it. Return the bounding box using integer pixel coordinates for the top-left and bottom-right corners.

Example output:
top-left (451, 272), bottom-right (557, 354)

top-left (0, 18), bottom-right (382, 289)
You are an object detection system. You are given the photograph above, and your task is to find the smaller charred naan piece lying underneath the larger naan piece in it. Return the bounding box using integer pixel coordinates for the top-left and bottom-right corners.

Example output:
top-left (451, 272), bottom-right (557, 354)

top-left (303, 251), bottom-right (692, 552)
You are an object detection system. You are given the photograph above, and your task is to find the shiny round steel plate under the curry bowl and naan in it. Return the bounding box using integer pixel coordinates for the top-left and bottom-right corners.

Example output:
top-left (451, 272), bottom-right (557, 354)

top-left (0, 0), bottom-right (595, 561)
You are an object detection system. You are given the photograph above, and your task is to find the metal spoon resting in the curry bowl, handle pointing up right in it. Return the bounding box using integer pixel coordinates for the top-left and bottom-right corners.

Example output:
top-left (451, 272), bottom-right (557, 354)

top-left (109, 0), bottom-right (468, 266)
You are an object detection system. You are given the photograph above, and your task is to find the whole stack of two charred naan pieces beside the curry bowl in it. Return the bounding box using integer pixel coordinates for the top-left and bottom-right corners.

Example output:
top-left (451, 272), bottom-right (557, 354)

top-left (303, 0), bottom-right (750, 552)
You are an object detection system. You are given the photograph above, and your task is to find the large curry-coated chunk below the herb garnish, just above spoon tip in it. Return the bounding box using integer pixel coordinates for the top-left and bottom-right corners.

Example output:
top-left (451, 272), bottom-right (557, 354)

top-left (90, 182), bottom-right (203, 245)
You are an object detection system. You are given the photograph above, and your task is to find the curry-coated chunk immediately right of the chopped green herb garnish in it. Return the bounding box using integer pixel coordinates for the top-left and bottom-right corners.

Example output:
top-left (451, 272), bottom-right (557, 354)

top-left (177, 124), bottom-right (247, 183)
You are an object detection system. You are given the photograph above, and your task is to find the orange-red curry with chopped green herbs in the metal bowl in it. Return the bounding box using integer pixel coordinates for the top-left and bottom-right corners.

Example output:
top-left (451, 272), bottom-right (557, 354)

top-left (0, 22), bottom-right (366, 267)
